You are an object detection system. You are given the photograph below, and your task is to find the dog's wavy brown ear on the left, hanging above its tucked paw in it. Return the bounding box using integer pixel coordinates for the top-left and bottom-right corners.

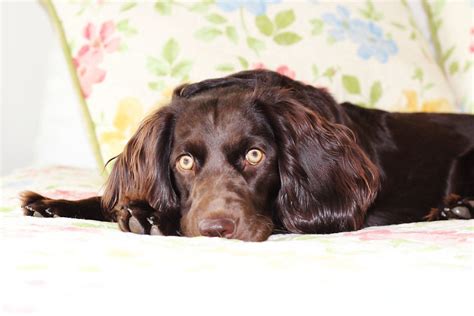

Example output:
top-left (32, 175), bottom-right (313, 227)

top-left (102, 107), bottom-right (179, 213)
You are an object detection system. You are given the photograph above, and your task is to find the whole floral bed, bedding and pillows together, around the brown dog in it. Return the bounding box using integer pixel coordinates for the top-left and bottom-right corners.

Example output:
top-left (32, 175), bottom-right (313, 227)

top-left (0, 0), bottom-right (474, 316)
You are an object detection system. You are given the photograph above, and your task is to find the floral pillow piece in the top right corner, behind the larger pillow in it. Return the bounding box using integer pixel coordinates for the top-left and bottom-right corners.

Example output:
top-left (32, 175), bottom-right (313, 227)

top-left (423, 0), bottom-right (474, 113)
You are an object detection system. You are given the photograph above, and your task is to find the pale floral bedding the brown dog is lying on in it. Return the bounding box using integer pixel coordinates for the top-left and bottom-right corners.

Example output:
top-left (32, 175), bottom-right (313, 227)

top-left (0, 167), bottom-right (474, 315)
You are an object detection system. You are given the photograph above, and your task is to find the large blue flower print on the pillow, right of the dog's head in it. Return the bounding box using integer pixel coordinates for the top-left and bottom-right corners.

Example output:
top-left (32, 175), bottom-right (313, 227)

top-left (322, 6), bottom-right (398, 63)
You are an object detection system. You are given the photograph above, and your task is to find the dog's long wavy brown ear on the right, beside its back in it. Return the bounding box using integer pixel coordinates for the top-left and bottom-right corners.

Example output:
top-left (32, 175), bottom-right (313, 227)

top-left (257, 88), bottom-right (379, 233)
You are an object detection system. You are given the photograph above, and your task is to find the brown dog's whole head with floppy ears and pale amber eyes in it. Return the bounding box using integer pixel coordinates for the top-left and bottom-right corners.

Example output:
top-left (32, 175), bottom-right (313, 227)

top-left (103, 71), bottom-right (378, 241)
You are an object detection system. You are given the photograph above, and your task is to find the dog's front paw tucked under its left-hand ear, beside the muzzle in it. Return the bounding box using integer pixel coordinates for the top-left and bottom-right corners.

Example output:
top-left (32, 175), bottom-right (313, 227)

top-left (117, 201), bottom-right (163, 235)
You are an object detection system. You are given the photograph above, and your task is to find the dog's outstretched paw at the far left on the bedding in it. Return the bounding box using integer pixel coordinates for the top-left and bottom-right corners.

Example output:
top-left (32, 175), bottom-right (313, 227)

top-left (20, 191), bottom-right (60, 217)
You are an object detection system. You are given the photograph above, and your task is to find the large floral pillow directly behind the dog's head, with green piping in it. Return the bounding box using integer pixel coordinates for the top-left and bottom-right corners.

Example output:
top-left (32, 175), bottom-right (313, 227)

top-left (46, 0), bottom-right (462, 172)
